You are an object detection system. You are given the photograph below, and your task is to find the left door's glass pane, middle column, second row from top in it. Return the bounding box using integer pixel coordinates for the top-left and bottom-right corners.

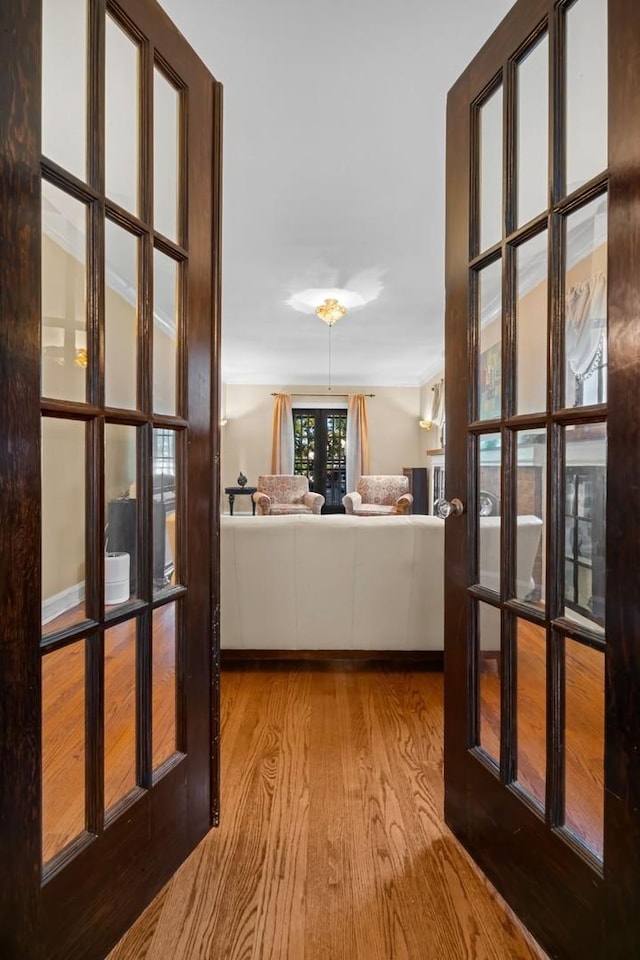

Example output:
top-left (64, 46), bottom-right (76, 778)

top-left (104, 220), bottom-right (138, 410)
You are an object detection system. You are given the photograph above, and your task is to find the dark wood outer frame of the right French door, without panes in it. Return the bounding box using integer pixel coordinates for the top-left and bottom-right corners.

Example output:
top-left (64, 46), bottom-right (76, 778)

top-left (445, 0), bottom-right (640, 960)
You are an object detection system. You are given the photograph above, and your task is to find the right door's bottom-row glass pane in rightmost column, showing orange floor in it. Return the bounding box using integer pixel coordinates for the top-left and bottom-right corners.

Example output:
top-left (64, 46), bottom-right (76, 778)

top-left (564, 639), bottom-right (604, 859)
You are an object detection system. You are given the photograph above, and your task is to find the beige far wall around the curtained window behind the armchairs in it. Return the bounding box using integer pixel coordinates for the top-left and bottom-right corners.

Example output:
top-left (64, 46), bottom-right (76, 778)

top-left (221, 384), bottom-right (425, 513)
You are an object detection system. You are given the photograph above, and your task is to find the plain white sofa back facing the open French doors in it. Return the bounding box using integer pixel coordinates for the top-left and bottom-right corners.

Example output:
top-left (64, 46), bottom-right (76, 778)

top-left (220, 515), bottom-right (444, 650)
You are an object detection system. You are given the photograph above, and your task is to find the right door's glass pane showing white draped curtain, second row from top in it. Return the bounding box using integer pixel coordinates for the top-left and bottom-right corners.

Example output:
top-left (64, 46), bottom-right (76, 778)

top-left (565, 197), bottom-right (607, 407)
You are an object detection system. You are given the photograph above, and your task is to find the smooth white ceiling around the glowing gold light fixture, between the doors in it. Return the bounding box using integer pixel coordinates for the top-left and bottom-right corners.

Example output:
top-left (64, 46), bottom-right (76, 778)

top-left (161, 0), bottom-right (512, 386)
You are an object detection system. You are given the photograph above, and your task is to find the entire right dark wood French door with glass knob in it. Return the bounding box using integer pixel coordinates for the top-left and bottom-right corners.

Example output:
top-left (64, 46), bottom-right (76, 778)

top-left (445, 0), bottom-right (640, 960)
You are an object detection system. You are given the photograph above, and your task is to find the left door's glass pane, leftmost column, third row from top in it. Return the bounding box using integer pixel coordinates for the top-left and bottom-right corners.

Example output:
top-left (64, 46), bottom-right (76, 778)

top-left (41, 417), bottom-right (86, 633)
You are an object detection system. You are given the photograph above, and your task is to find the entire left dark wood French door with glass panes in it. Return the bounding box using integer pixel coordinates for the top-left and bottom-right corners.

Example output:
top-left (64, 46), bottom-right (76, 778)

top-left (0, 0), bottom-right (221, 960)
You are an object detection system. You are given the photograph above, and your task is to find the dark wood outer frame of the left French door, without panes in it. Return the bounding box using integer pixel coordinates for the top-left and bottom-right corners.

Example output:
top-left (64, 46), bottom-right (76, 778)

top-left (0, 0), bottom-right (222, 958)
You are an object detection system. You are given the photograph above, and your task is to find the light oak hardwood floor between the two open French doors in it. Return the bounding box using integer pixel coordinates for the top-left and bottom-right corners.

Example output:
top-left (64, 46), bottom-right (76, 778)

top-left (109, 666), bottom-right (545, 960)
